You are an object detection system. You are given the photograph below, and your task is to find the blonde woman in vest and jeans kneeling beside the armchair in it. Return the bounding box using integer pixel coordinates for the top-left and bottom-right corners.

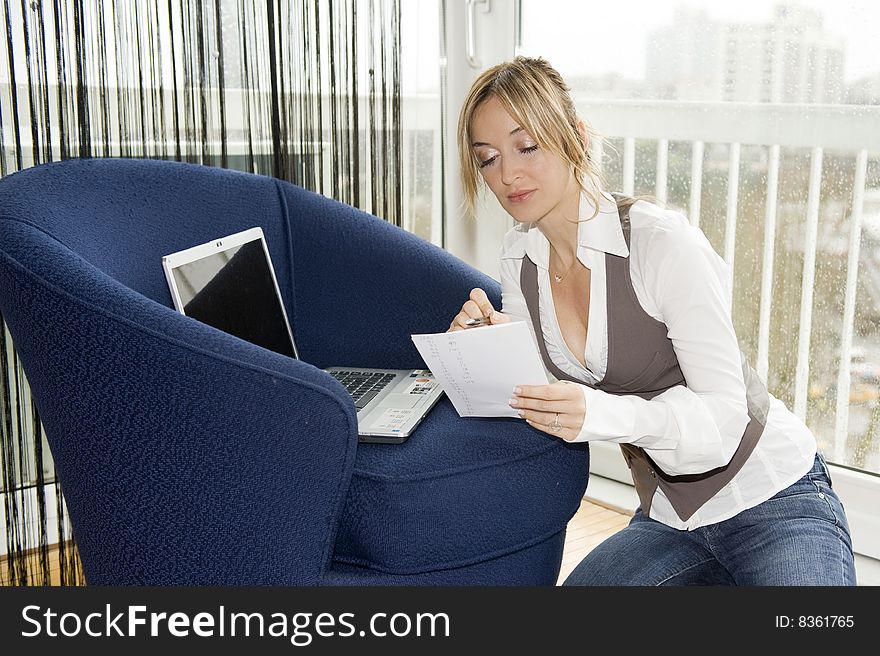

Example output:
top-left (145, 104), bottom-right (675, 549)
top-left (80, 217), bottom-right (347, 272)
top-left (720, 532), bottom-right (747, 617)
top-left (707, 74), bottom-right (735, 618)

top-left (450, 57), bottom-right (855, 585)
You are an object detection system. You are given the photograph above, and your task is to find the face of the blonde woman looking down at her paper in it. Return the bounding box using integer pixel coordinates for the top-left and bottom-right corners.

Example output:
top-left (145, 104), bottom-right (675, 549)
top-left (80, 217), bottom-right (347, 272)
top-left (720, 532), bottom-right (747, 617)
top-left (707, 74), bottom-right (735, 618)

top-left (471, 97), bottom-right (580, 222)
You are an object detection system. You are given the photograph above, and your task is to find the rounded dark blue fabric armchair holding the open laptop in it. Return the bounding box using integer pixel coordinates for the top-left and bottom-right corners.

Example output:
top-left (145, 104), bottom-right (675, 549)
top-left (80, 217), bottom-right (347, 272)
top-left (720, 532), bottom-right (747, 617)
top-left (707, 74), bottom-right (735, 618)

top-left (0, 159), bottom-right (589, 585)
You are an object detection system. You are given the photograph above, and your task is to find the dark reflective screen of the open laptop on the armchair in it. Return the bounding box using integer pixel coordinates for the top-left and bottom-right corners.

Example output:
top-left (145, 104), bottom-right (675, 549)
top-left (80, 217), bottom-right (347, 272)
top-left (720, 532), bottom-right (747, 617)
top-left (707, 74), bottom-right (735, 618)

top-left (167, 236), bottom-right (297, 358)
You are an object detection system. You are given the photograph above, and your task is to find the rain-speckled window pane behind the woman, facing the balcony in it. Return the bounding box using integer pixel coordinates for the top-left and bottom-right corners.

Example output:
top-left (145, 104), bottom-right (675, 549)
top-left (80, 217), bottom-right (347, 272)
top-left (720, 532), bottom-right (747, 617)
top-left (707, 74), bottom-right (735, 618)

top-left (519, 0), bottom-right (880, 473)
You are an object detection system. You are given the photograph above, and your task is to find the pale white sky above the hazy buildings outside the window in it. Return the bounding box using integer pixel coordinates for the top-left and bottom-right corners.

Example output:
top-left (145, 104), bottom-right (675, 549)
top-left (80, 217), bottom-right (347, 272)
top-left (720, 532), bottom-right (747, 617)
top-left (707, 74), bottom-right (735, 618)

top-left (522, 0), bottom-right (880, 83)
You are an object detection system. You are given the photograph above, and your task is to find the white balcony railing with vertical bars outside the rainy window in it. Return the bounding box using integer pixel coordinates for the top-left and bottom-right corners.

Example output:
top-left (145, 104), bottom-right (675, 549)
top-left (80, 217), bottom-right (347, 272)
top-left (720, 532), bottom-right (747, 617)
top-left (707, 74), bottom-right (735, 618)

top-left (578, 101), bottom-right (880, 472)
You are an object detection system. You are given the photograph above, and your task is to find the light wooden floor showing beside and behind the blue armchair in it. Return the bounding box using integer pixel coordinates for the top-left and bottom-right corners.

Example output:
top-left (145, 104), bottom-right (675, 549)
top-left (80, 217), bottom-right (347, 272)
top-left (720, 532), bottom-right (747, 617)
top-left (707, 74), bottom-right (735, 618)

top-left (0, 499), bottom-right (630, 586)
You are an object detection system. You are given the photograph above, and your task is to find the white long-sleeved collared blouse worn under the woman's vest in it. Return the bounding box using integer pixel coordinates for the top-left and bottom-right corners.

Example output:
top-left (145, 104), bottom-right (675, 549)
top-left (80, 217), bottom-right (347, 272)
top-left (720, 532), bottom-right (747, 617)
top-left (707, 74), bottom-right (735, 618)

top-left (501, 194), bottom-right (816, 529)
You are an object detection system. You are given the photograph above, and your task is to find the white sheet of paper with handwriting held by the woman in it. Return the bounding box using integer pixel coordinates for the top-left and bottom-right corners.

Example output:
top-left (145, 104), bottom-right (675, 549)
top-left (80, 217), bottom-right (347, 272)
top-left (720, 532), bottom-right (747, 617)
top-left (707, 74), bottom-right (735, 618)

top-left (412, 321), bottom-right (549, 417)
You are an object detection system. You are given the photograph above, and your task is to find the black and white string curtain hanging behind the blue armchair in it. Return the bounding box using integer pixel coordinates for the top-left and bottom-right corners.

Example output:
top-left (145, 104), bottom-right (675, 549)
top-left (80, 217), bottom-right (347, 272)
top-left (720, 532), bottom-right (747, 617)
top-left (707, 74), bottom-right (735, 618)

top-left (0, 0), bottom-right (402, 585)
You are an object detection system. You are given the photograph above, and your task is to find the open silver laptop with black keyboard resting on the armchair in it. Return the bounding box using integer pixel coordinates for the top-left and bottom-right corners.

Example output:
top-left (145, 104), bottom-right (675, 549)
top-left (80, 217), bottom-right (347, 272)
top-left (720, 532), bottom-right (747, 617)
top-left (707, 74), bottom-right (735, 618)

top-left (162, 228), bottom-right (443, 444)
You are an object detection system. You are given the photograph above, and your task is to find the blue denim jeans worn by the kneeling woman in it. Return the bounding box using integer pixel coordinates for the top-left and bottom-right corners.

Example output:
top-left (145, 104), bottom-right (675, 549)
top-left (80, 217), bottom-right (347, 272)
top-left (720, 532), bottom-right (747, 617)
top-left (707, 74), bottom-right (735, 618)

top-left (564, 455), bottom-right (856, 586)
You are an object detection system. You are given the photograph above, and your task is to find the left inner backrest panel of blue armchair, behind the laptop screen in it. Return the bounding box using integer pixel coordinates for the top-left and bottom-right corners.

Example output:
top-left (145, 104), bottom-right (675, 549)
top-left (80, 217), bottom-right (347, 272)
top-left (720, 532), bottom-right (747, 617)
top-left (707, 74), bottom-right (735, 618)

top-left (0, 159), bottom-right (290, 306)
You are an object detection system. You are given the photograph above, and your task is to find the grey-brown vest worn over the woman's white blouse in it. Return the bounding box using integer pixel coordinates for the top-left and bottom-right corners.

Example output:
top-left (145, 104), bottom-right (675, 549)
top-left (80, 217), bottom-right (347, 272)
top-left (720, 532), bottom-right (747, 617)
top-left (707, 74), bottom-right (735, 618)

top-left (520, 194), bottom-right (770, 521)
